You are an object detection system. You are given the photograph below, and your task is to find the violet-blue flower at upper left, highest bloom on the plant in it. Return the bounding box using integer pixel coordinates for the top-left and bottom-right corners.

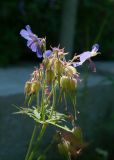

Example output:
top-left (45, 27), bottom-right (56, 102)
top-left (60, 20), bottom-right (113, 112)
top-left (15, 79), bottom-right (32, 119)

top-left (20, 25), bottom-right (43, 58)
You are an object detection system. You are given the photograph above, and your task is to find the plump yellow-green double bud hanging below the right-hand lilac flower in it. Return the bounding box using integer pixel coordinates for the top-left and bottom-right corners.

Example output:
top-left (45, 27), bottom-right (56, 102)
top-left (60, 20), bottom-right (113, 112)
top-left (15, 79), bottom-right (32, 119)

top-left (60, 76), bottom-right (77, 91)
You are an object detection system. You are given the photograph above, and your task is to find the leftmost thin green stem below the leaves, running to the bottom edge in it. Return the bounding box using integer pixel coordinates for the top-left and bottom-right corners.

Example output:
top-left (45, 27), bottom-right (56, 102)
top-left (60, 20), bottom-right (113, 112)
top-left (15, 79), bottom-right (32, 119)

top-left (25, 125), bottom-right (37, 160)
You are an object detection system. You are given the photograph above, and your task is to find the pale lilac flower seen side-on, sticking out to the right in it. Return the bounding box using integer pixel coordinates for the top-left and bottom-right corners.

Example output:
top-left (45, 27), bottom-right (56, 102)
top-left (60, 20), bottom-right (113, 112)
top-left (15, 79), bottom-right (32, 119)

top-left (73, 44), bottom-right (99, 67)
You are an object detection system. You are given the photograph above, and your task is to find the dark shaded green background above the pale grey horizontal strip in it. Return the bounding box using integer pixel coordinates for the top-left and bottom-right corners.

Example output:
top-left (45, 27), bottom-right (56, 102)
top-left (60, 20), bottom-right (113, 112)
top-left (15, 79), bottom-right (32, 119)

top-left (0, 0), bottom-right (114, 66)
